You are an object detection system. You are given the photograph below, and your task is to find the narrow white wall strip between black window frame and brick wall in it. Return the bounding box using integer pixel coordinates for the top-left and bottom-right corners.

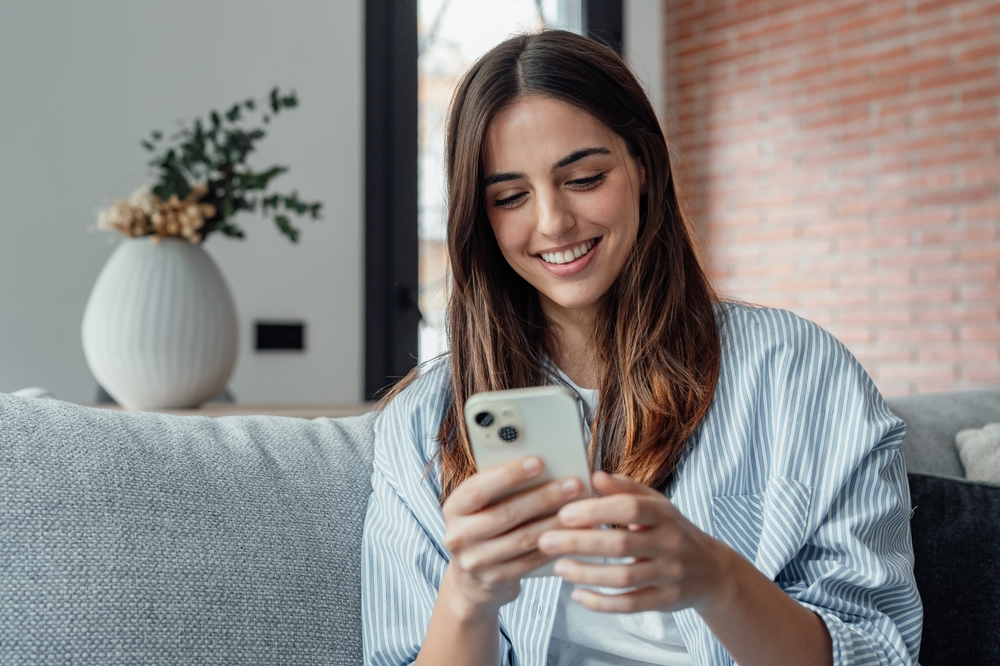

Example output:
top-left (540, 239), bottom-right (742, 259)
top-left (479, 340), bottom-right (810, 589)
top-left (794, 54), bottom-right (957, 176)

top-left (622, 0), bottom-right (663, 123)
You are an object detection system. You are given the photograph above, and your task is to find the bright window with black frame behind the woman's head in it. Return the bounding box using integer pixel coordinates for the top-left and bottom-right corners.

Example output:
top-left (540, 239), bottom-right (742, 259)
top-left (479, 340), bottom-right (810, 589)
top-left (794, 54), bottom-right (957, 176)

top-left (365, 0), bottom-right (622, 397)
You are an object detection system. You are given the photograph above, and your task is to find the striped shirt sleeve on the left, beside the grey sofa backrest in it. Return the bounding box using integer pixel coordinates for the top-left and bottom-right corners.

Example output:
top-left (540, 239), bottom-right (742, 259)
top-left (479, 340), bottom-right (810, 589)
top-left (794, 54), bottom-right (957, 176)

top-left (361, 364), bottom-right (510, 666)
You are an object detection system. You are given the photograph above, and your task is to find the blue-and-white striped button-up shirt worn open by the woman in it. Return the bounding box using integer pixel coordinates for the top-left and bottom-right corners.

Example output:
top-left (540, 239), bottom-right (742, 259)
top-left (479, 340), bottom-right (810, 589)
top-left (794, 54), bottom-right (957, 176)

top-left (362, 304), bottom-right (923, 666)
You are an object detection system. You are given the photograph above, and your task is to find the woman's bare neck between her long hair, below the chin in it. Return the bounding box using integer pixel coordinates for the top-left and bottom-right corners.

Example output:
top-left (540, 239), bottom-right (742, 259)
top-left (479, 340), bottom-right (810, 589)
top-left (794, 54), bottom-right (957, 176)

top-left (542, 298), bottom-right (600, 388)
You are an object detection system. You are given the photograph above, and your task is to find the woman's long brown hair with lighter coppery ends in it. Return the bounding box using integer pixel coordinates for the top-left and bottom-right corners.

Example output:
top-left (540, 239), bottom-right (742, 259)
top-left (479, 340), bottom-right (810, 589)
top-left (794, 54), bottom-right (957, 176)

top-left (389, 30), bottom-right (721, 503)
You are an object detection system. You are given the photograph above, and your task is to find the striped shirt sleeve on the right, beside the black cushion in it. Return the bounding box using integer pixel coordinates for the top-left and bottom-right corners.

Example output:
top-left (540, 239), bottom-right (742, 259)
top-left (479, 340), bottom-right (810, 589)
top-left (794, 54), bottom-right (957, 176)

top-left (756, 310), bottom-right (923, 666)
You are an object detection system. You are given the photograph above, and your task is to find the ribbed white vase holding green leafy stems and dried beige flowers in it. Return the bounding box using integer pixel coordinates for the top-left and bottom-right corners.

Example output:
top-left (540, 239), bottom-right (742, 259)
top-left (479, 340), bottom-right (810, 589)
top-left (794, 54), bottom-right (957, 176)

top-left (82, 88), bottom-right (322, 409)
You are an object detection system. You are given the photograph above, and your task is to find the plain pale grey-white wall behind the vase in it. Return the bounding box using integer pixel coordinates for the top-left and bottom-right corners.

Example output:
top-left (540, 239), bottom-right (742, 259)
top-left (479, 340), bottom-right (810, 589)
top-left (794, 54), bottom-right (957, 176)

top-left (0, 0), bottom-right (364, 403)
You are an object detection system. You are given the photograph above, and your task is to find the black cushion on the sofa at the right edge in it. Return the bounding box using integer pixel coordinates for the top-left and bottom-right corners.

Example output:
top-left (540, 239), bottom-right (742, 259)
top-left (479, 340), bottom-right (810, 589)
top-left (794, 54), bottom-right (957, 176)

top-left (907, 474), bottom-right (1000, 664)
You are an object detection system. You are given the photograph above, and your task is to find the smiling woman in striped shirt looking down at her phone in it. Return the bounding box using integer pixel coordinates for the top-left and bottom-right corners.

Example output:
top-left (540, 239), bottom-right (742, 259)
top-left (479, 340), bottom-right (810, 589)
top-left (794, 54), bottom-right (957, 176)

top-left (363, 31), bottom-right (922, 666)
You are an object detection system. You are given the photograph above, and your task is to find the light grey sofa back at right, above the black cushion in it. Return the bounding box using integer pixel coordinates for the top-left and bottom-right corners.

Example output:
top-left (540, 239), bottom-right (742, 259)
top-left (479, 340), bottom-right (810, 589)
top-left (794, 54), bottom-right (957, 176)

top-left (886, 388), bottom-right (1000, 478)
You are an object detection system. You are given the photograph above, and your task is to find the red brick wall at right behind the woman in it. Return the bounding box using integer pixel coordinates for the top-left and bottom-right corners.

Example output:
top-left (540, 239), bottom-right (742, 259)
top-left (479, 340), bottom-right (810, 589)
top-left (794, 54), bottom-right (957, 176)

top-left (664, 0), bottom-right (1000, 395)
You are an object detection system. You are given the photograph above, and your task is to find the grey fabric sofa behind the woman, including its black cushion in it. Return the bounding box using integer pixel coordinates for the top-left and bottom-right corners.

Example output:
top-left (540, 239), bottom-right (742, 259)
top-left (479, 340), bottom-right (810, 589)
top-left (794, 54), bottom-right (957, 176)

top-left (0, 389), bottom-right (1000, 666)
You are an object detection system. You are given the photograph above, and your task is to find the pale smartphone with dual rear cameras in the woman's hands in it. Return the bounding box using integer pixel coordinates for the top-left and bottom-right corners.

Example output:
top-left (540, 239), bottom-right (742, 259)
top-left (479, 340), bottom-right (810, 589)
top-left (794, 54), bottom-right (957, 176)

top-left (465, 386), bottom-right (603, 578)
